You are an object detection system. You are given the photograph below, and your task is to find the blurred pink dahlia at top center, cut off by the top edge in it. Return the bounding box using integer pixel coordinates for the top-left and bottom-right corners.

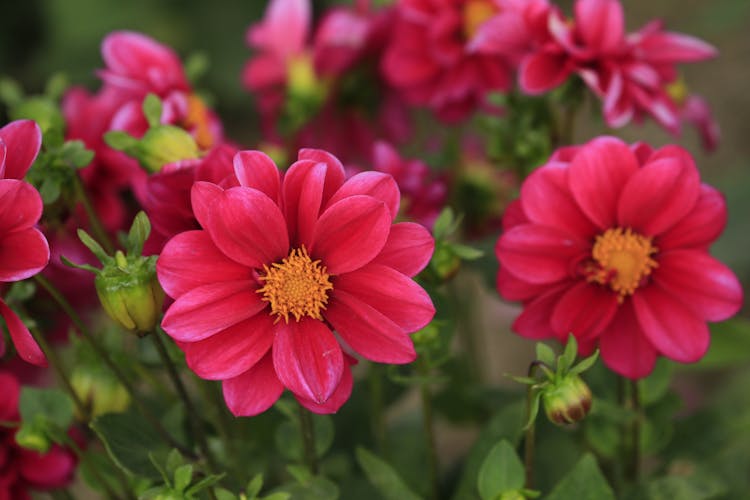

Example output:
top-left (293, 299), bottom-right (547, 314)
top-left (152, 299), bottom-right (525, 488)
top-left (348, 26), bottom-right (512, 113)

top-left (381, 0), bottom-right (512, 122)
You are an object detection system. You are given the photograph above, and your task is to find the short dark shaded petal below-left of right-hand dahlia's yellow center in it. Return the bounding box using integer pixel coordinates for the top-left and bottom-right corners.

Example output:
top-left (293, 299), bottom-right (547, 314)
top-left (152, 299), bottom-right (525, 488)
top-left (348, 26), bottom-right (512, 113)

top-left (551, 281), bottom-right (617, 339)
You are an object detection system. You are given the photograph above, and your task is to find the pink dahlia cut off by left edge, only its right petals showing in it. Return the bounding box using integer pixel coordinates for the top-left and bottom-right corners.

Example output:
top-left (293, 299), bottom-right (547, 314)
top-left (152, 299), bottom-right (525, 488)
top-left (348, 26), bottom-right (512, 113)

top-left (0, 120), bottom-right (49, 366)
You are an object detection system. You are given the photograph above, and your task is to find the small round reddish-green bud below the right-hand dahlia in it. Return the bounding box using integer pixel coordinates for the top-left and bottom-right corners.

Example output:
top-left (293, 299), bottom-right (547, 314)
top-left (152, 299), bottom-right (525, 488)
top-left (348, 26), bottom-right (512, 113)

top-left (542, 375), bottom-right (591, 425)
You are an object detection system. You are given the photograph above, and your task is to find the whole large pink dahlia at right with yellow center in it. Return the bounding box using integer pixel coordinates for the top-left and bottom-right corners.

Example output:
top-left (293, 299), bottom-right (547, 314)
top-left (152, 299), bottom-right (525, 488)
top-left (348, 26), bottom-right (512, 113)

top-left (495, 137), bottom-right (742, 379)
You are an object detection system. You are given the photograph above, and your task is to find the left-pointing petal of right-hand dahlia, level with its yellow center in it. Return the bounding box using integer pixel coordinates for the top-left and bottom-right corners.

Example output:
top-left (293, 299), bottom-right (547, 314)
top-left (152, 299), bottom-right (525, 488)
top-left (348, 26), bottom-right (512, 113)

top-left (495, 224), bottom-right (589, 284)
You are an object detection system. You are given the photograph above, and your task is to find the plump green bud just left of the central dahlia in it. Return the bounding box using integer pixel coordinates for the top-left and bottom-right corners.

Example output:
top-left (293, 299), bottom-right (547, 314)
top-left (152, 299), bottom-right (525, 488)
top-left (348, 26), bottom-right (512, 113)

top-left (94, 250), bottom-right (164, 334)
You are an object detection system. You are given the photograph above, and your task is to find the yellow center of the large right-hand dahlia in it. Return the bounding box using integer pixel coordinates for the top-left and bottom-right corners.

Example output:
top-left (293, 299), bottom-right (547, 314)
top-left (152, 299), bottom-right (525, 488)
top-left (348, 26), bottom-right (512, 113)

top-left (584, 227), bottom-right (659, 303)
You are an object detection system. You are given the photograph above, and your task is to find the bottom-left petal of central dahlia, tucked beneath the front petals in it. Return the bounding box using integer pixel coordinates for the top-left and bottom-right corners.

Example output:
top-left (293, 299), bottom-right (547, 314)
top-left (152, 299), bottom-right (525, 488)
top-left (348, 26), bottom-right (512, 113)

top-left (221, 352), bottom-right (284, 417)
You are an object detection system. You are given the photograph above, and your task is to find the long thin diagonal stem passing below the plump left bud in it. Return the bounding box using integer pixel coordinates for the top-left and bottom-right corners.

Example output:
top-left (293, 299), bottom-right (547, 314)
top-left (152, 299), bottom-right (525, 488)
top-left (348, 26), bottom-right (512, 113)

top-left (34, 274), bottom-right (196, 459)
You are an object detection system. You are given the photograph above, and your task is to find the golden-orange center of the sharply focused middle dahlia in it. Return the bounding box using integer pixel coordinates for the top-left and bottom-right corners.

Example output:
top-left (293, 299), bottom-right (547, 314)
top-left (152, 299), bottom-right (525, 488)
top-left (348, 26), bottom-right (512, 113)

top-left (257, 246), bottom-right (333, 323)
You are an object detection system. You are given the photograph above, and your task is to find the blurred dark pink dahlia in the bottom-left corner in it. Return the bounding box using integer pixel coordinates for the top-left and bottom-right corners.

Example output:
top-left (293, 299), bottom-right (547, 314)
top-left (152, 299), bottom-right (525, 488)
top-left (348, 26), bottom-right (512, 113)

top-left (0, 372), bottom-right (77, 500)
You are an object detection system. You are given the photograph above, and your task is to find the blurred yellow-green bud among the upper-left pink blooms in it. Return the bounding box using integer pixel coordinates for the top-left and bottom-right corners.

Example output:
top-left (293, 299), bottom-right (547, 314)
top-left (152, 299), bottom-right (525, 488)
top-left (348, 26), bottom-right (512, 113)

top-left (137, 125), bottom-right (200, 172)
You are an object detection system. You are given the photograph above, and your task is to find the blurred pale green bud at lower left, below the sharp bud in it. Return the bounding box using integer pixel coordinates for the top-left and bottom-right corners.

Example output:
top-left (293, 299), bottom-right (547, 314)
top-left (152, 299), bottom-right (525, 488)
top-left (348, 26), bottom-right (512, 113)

top-left (70, 366), bottom-right (130, 417)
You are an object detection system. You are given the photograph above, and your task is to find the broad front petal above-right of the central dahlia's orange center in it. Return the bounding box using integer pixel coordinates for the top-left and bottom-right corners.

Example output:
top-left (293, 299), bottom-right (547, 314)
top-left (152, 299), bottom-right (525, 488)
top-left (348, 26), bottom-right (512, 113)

top-left (310, 195), bottom-right (391, 275)
